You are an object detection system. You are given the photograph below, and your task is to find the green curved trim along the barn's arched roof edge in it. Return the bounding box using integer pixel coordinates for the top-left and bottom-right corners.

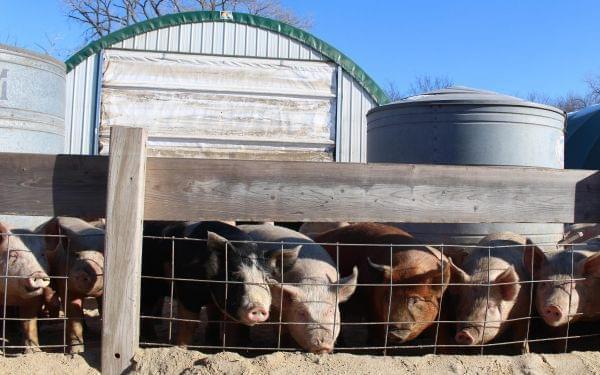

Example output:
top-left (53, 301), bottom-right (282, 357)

top-left (65, 11), bottom-right (389, 105)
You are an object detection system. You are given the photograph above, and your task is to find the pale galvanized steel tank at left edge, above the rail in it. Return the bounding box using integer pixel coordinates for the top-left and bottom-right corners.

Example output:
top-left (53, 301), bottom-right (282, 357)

top-left (0, 45), bottom-right (66, 154)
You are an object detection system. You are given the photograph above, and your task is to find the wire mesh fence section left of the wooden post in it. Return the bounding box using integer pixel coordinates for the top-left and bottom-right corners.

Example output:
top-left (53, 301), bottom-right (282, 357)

top-left (0, 229), bottom-right (103, 356)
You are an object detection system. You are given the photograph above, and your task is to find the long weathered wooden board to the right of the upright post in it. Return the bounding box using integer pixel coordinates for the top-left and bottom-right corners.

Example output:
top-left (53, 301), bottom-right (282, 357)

top-left (146, 159), bottom-right (600, 223)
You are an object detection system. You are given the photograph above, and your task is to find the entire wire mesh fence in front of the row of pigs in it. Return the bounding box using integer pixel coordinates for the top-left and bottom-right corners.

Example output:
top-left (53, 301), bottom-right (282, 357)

top-left (0, 223), bottom-right (600, 355)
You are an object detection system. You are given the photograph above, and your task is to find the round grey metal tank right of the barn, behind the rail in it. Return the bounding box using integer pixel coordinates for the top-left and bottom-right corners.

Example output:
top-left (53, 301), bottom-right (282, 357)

top-left (367, 87), bottom-right (565, 248)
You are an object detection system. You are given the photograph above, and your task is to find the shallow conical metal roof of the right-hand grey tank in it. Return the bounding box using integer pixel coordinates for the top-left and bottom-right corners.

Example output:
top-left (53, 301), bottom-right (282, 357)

top-left (369, 86), bottom-right (565, 116)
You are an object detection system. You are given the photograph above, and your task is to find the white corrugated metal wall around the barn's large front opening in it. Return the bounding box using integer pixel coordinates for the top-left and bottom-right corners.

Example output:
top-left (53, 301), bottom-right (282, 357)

top-left (65, 22), bottom-right (375, 162)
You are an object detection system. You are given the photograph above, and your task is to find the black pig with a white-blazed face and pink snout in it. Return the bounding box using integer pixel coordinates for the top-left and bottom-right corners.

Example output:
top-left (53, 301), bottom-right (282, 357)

top-left (142, 221), bottom-right (300, 346)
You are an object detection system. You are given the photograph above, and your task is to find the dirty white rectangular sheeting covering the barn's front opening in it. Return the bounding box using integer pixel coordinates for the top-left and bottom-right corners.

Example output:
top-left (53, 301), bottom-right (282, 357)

top-left (100, 50), bottom-right (337, 161)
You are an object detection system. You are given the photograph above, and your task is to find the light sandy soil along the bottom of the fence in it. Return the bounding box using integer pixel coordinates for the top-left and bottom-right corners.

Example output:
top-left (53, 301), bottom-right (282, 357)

top-left (0, 348), bottom-right (600, 375)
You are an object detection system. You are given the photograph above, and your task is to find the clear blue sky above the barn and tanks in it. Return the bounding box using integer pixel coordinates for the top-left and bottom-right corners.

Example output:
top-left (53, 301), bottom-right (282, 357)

top-left (0, 0), bottom-right (600, 97)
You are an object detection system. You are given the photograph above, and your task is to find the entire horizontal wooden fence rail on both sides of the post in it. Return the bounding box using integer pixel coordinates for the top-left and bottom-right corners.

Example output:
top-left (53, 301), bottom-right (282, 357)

top-left (0, 154), bottom-right (600, 223)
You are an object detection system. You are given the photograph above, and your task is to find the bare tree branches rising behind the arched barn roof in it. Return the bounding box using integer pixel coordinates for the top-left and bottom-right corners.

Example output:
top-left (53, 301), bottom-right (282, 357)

top-left (63, 0), bottom-right (312, 40)
